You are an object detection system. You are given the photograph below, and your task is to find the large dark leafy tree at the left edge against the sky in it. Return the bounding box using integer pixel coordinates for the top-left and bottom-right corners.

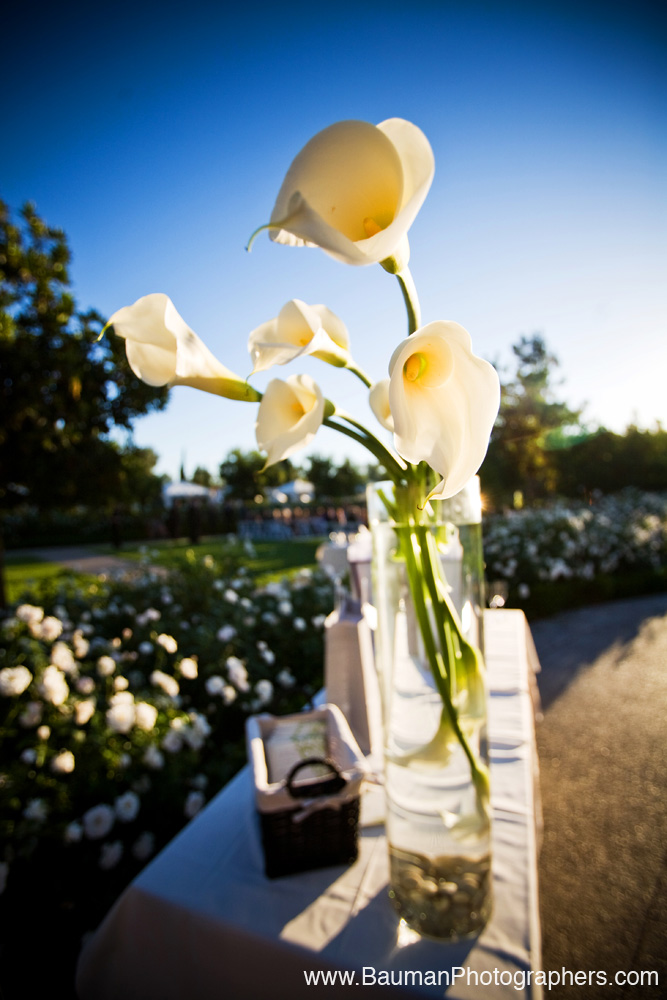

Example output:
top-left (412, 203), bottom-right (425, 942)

top-left (0, 201), bottom-right (167, 596)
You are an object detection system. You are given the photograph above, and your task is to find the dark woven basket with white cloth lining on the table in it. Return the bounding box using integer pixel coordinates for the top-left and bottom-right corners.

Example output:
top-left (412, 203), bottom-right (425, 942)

top-left (246, 705), bottom-right (366, 878)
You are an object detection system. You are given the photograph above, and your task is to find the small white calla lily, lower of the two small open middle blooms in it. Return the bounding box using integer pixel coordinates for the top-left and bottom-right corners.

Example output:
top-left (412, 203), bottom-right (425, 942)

top-left (255, 375), bottom-right (325, 468)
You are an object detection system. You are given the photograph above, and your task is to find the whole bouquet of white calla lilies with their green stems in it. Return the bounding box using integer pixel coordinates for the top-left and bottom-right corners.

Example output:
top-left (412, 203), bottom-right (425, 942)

top-left (108, 118), bottom-right (500, 815)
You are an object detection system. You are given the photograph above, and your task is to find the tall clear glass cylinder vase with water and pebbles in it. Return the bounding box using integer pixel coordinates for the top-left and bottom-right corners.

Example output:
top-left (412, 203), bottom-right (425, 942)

top-left (368, 480), bottom-right (492, 940)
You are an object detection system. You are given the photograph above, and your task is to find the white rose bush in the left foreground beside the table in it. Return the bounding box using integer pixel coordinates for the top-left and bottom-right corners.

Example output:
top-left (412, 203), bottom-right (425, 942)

top-left (0, 536), bottom-right (333, 942)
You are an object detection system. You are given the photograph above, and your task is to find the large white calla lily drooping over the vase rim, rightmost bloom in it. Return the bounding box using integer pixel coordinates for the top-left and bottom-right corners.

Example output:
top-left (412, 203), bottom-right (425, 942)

top-left (389, 322), bottom-right (500, 500)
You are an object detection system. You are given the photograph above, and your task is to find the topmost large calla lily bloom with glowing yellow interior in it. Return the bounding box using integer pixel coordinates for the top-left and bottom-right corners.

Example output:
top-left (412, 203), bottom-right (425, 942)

top-left (254, 118), bottom-right (434, 270)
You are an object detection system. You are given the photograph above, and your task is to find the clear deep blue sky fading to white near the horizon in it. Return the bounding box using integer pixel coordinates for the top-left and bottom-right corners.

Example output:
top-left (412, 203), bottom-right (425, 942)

top-left (5, 0), bottom-right (667, 475)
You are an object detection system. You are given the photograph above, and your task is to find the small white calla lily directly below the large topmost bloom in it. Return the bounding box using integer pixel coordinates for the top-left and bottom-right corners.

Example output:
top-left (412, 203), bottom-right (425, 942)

top-left (248, 299), bottom-right (351, 373)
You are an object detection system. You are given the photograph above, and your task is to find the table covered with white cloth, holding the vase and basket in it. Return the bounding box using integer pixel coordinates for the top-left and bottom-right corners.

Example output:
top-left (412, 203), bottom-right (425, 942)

top-left (77, 609), bottom-right (541, 1000)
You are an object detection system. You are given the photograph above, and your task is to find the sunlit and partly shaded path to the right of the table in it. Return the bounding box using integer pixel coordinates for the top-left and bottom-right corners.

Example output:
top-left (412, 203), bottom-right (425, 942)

top-left (531, 594), bottom-right (667, 1000)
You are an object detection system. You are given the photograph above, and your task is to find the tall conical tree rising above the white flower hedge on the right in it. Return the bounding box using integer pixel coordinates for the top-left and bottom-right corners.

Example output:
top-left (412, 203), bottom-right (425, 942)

top-left (480, 334), bottom-right (581, 506)
